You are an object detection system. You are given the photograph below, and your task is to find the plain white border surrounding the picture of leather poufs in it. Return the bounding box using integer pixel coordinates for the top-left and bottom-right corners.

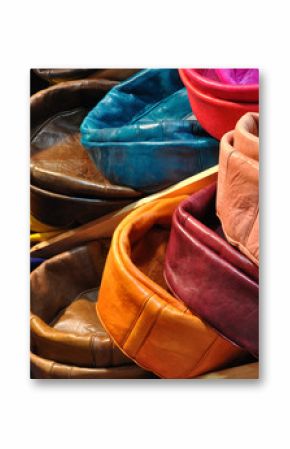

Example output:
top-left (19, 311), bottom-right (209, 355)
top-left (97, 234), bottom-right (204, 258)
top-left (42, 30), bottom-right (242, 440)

top-left (0, 0), bottom-right (290, 449)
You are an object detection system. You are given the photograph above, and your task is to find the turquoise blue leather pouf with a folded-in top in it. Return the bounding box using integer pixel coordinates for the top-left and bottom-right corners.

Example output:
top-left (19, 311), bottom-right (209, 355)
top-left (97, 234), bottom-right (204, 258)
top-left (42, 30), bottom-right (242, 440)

top-left (81, 69), bottom-right (219, 193)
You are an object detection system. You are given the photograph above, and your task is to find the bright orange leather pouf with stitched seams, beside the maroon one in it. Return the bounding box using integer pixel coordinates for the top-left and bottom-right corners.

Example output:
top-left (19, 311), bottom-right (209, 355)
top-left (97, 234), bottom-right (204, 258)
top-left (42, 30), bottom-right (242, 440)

top-left (96, 196), bottom-right (245, 378)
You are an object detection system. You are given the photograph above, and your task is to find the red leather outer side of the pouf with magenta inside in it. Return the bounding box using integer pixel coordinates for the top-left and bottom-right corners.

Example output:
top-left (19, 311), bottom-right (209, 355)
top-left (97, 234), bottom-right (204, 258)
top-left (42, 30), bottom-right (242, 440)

top-left (179, 69), bottom-right (259, 140)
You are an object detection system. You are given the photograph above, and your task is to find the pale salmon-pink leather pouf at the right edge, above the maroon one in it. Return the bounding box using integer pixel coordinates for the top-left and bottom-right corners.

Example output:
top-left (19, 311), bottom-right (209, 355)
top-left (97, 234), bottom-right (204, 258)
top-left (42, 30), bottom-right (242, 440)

top-left (217, 113), bottom-right (259, 265)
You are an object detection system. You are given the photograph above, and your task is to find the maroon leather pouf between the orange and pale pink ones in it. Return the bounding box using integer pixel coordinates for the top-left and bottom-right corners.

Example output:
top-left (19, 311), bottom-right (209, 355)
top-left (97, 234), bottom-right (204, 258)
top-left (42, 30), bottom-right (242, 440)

top-left (164, 184), bottom-right (259, 357)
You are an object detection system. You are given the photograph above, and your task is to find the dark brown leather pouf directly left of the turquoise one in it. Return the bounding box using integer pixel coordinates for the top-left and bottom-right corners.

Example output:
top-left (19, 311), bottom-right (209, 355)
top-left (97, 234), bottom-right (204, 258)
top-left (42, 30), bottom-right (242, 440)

top-left (31, 80), bottom-right (141, 227)
